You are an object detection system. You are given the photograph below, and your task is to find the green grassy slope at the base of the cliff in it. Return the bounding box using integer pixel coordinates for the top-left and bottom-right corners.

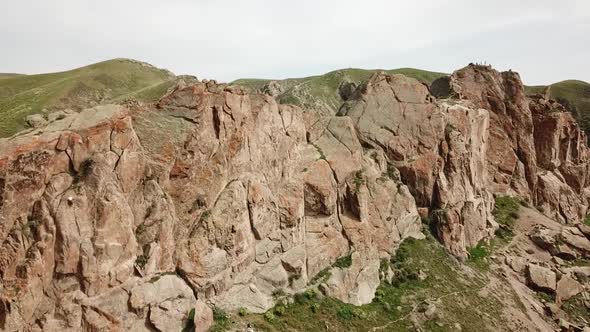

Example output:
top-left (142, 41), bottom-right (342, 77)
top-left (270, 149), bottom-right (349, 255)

top-left (214, 236), bottom-right (518, 331)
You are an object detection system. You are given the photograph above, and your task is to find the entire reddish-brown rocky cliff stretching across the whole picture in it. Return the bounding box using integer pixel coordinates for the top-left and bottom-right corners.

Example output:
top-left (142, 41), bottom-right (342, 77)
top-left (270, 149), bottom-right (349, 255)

top-left (0, 66), bottom-right (588, 331)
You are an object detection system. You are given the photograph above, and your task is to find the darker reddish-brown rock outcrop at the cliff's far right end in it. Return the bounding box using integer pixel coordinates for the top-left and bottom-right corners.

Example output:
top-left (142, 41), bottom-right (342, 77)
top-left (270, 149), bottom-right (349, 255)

top-left (448, 65), bottom-right (589, 224)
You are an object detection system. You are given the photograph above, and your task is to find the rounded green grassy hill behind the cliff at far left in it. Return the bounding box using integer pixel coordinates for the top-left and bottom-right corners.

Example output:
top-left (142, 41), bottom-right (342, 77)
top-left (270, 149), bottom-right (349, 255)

top-left (0, 59), bottom-right (175, 137)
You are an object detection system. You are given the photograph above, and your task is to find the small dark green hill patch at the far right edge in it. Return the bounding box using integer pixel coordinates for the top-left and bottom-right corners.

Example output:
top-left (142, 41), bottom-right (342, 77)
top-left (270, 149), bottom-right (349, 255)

top-left (526, 80), bottom-right (590, 134)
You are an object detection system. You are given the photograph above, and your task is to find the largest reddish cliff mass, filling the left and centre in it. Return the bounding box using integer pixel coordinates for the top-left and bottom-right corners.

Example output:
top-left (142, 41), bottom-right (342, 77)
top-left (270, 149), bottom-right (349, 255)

top-left (0, 81), bottom-right (421, 330)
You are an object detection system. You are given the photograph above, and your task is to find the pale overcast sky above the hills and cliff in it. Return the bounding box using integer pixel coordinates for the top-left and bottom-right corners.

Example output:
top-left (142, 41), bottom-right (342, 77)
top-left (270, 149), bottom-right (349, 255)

top-left (0, 0), bottom-right (590, 84)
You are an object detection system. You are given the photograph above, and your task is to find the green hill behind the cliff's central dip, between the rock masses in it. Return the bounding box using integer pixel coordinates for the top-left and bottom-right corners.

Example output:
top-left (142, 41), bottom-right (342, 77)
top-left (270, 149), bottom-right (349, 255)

top-left (232, 68), bottom-right (447, 113)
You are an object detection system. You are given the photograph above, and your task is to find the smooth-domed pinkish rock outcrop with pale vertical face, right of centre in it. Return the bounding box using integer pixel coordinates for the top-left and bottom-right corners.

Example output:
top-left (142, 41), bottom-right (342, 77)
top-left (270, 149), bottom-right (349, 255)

top-left (339, 74), bottom-right (497, 258)
